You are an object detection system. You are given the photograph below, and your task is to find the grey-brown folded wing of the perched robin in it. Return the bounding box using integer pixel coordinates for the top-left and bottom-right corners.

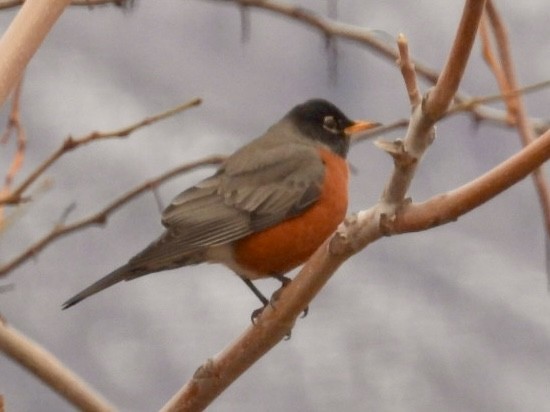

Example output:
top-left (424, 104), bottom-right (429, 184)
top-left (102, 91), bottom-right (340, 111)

top-left (129, 143), bottom-right (324, 268)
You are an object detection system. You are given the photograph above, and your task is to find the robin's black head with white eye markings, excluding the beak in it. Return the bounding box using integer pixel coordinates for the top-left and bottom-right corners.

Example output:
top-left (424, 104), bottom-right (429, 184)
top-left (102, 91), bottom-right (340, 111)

top-left (286, 99), bottom-right (364, 158)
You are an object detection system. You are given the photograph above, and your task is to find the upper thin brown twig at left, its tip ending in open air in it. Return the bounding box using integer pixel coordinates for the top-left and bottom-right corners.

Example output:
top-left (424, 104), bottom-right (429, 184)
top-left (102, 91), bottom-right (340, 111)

top-left (0, 98), bottom-right (201, 205)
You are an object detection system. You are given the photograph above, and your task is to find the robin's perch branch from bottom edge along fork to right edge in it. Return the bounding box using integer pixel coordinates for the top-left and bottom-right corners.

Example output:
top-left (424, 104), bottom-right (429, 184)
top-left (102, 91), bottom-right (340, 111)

top-left (166, 125), bottom-right (550, 412)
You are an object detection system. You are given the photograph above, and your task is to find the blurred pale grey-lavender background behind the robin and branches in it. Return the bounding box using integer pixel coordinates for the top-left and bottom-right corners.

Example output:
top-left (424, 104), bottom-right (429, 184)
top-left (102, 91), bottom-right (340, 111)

top-left (0, 0), bottom-right (550, 411)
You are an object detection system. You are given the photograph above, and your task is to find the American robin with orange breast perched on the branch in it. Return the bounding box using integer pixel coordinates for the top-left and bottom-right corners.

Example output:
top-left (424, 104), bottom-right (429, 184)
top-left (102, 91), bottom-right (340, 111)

top-left (63, 99), bottom-right (378, 309)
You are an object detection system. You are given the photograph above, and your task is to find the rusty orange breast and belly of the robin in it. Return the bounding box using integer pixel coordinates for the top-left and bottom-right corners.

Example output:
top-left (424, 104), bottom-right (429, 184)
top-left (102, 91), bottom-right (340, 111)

top-left (234, 149), bottom-right (348, 278)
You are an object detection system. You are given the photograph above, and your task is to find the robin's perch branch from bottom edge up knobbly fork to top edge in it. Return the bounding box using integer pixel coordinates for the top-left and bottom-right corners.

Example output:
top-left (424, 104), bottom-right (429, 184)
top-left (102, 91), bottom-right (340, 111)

top-left (162, 0), bottom-right (494, 412)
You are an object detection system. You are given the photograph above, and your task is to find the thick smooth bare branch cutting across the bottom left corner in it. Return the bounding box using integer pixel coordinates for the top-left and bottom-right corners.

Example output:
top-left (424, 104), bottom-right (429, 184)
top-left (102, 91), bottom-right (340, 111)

top-left (0, 320), bottom-right (115, 412)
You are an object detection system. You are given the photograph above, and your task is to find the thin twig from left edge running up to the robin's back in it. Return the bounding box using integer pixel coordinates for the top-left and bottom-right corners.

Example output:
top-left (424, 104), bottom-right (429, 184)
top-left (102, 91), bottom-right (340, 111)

top-left (0, 156), bottom-right (225, 277)
